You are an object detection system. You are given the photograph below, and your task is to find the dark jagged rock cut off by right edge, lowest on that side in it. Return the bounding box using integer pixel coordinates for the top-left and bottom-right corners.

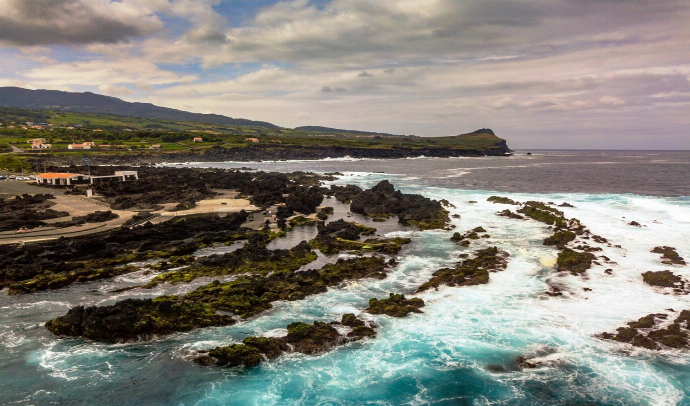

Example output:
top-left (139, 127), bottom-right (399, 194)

top-left (600, 310), bottom-right (690, 350)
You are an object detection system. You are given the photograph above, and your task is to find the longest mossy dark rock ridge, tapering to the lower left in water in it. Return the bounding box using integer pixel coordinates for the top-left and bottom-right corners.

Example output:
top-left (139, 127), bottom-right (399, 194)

top-left (46, 257), bottom-right (388, 342)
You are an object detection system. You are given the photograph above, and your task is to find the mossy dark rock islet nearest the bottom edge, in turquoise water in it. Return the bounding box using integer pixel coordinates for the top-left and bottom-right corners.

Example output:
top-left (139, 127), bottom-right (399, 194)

top-left (194, 313), bottom-right (376, 367)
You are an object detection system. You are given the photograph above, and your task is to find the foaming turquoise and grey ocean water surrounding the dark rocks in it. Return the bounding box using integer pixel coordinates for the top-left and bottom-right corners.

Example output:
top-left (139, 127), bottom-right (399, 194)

top-left (0, 151), bottom-right (690, 406)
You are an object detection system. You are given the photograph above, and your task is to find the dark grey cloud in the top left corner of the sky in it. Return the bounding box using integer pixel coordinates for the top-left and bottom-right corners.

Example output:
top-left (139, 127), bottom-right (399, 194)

top-left (0, 0), bottom-right (162, 45)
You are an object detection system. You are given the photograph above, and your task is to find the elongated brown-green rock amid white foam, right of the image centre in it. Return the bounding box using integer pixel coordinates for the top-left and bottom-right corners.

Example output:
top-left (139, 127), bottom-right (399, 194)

top-left (417, 247), bottom-right (508, 292)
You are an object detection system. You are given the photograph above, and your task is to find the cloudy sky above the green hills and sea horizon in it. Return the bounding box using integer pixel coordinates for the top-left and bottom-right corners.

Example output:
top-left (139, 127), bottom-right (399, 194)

top-left (0, 0), bottom-right (690, 149)
